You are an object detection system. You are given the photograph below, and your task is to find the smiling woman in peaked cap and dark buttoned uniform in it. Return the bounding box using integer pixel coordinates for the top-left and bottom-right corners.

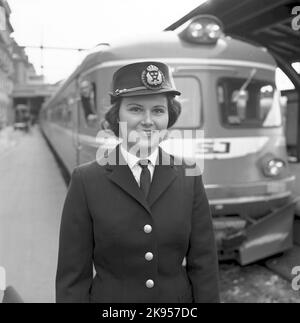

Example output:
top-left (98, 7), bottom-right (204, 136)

top-left (56, 62), bottom-right (219, 303)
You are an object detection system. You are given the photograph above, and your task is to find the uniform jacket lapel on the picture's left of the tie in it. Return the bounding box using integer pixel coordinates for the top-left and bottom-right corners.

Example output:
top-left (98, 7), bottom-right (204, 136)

top-left (105, 146), bottom-right (151, 213)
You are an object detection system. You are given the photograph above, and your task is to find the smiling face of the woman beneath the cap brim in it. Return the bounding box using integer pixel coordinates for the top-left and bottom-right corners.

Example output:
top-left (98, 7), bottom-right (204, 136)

top-left (119, 94), bottom-right (169, 155)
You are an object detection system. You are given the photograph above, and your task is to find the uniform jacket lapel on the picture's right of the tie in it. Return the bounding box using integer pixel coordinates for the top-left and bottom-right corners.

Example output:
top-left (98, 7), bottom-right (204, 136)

top-left (148, 148), bottom-right (177, 206)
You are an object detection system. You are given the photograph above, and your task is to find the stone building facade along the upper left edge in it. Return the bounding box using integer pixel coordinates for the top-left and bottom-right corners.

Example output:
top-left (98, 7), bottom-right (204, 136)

top-left (0, 0), bottom-right (57, 129)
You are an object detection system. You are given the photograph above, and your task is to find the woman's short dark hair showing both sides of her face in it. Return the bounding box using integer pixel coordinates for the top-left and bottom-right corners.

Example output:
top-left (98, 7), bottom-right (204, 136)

top-left (105, 94), bottom-right (181, 137)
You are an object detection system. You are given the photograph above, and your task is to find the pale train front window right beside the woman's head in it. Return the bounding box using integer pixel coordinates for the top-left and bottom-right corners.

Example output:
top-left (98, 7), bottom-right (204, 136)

top-left (173, 76), bottom-right (202, 128)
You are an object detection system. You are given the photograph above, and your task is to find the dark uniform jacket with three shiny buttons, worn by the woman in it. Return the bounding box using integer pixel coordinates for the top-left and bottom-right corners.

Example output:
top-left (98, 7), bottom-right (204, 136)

top-left (56, 148), bottom-right (219, 303)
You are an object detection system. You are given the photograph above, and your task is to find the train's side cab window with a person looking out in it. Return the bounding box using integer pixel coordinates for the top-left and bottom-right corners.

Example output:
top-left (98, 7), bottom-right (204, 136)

top-left (79, 80), bottom-right (98, 126)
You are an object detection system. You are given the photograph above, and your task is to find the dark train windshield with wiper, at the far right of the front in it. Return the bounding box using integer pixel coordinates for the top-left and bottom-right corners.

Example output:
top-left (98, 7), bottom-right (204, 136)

top-left (217, 78), bottom-right (281, 128)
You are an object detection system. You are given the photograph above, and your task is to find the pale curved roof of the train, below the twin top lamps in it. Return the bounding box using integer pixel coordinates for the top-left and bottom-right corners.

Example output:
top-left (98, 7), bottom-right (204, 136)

top-left (48, 31), bottom-right (276, 107)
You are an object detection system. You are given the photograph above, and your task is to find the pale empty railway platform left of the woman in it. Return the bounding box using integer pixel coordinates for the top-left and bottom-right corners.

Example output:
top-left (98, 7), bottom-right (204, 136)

top-left (0, 127), bottom-right (66, 302)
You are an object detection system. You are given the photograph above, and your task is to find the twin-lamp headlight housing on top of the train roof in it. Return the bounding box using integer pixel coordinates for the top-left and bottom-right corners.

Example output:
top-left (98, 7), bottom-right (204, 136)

top-left (179, 15), bottom-right (223, 44)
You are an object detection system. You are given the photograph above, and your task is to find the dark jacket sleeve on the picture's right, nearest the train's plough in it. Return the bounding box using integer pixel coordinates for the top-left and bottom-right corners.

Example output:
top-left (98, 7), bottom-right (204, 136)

top-left (186, 176), bottom-right (220, 303)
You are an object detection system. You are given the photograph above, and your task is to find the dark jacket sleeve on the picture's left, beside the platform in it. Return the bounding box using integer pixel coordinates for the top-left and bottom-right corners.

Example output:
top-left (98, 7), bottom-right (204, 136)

top-left (56, 168), bottom-right (94, 303)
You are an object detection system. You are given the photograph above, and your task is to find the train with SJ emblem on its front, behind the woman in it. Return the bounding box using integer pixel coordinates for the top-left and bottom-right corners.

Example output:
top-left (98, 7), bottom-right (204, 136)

top-left (40, 15), bottom-right (295, 265)
